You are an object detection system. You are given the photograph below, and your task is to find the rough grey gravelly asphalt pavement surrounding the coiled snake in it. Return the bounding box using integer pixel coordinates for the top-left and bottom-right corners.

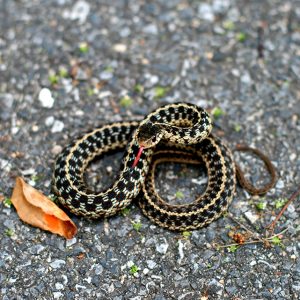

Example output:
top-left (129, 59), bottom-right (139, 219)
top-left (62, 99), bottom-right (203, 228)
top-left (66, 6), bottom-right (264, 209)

top-left (0, 0), bottom-right (300, 300)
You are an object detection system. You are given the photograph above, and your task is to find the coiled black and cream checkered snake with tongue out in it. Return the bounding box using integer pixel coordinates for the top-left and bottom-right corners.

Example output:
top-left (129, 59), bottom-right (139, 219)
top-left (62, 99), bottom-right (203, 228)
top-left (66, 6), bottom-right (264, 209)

top-left (53, 102), bottom-right (275, 231)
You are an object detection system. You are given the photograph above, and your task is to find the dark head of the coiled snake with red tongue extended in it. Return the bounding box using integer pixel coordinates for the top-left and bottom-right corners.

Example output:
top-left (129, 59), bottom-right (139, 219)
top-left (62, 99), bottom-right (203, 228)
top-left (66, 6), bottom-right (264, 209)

top-left (132, 122), bottom-right (163, 168)
